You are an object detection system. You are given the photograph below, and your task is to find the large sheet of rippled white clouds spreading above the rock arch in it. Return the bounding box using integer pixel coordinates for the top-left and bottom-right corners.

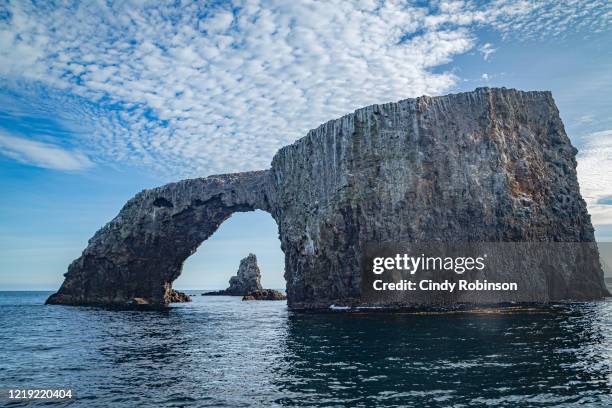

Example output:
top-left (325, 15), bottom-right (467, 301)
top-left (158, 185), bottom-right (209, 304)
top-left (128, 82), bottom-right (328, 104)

top-left (0, 0), bottom-right (609, 177)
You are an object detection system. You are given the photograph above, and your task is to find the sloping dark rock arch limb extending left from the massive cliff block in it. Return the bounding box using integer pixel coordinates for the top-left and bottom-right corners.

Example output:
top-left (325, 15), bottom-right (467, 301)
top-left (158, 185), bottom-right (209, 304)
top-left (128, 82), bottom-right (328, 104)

top-left (48, 171), bottom-right (270, 305)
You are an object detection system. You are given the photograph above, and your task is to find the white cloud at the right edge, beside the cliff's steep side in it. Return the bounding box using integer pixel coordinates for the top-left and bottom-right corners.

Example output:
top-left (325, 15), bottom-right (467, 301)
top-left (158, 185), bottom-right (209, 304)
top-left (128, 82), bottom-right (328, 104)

top-left (577, 129), bottom-right (612, 224)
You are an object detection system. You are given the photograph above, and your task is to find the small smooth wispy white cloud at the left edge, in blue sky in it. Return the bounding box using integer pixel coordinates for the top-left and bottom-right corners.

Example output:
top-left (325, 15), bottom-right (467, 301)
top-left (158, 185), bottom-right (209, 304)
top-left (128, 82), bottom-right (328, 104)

top-left (0, 131), bottom-right (92, 171)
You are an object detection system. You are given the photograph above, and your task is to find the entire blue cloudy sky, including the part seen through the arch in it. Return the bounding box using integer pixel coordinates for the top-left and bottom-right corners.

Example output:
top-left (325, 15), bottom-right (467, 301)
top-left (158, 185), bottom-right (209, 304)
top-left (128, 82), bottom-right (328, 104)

top-left (0, 0), bottom-right (612, 290)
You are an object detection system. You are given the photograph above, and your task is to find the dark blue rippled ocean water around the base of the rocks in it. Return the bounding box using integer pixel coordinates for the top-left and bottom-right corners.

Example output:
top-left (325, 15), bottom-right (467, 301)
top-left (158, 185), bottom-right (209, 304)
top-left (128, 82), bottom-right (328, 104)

top-left (0, 292), bottom-right (612, 407)
